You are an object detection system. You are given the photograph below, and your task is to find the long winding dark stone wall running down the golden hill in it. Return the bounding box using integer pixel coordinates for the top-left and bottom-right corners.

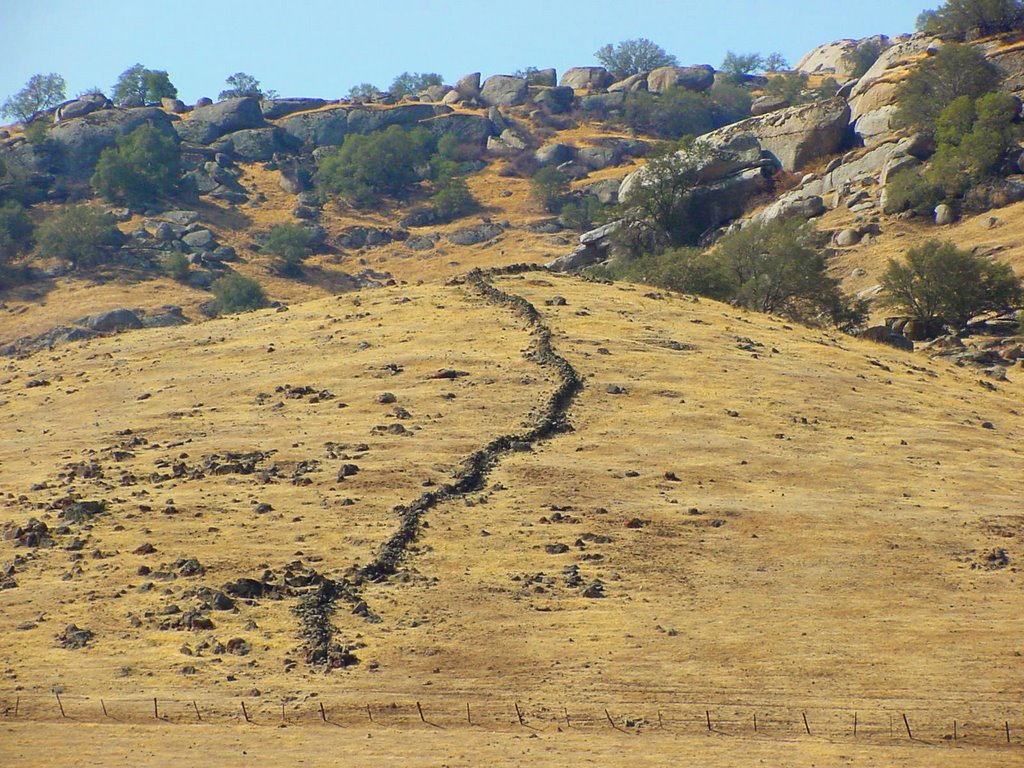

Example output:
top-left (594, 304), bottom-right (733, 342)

top-left (296, 264), bottom-right (583, 669)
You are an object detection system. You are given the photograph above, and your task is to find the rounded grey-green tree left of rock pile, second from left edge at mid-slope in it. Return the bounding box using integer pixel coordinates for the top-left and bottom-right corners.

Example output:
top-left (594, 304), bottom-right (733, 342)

top-left (36, 205), bottom-right (124, 269)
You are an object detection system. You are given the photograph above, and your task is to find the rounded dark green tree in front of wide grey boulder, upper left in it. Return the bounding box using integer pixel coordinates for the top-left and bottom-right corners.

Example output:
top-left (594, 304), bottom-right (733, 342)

top-left (91, 124), bottom-right (181, 207)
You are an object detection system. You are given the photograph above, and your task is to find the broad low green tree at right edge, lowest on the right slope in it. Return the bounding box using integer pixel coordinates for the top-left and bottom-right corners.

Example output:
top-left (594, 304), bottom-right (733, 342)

top-left (882, 240), bottom-right (1021, 329)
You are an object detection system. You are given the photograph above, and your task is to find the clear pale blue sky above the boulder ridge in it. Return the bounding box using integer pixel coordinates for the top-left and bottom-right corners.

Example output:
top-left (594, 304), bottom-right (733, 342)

top-left (0, 0), bottom-right (929, 102)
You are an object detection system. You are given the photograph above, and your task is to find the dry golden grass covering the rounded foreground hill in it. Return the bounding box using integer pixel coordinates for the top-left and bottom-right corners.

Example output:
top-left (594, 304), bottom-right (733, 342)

top-left (0, 274), bottom-right (1024, 766)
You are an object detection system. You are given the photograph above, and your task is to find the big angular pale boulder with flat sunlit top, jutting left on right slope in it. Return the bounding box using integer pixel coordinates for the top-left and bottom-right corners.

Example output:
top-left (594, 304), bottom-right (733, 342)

top-left (702, 98), bottom-right (850, 171)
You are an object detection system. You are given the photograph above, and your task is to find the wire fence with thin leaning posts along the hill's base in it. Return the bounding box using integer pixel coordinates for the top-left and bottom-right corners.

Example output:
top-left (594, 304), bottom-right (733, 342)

top-left (0, 693), bottom-right (1024, 751)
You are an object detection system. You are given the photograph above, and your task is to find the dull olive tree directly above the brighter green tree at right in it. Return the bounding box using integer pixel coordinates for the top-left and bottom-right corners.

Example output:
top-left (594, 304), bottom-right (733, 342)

top-left (896, 43), bottom-right (999, 133)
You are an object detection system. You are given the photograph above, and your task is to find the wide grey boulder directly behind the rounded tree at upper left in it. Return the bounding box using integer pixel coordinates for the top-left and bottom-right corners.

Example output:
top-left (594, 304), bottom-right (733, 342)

top-left (48, 106), bottom-right (178, 179)
